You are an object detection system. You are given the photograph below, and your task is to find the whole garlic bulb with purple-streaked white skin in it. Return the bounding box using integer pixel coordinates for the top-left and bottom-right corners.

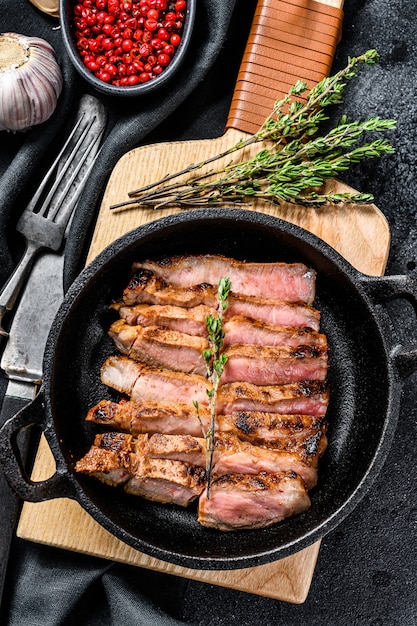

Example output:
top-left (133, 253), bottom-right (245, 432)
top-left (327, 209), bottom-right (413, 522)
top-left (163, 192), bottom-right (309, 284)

top-left (0, 33), bottom-right (63, 131)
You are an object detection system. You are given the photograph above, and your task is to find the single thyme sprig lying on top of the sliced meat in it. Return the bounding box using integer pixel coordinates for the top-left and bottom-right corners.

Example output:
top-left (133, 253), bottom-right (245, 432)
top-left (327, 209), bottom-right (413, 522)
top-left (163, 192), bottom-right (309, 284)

top-left (193, 277), bottom-right (231, 498)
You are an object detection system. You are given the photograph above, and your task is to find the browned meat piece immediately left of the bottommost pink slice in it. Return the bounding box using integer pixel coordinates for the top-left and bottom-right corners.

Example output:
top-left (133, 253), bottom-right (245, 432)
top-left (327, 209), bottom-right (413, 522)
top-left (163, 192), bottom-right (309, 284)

top-left (124, 455), bottom-right (206, 507)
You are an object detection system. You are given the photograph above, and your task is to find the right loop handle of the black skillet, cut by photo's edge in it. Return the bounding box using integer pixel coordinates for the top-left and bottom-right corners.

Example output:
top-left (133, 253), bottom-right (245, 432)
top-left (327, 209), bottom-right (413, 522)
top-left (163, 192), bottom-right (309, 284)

top-left (361, 275), bottom-right (417, 378)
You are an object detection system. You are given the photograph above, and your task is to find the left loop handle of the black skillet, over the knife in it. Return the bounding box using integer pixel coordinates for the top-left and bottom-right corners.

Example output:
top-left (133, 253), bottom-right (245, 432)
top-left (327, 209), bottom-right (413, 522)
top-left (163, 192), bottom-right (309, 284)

top-left (0, 391), bottom-right (74, 502)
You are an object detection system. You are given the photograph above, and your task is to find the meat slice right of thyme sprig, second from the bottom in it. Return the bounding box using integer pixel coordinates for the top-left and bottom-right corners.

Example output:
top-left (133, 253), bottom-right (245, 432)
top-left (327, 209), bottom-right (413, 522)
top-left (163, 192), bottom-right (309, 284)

top-left (213, 433), bottom-right (319, 489)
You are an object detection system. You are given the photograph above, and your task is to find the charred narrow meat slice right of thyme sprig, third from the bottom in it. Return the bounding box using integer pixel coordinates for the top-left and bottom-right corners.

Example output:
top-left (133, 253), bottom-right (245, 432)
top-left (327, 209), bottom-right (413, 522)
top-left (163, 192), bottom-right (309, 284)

top-left (216, 411), bottom-right (327, 446)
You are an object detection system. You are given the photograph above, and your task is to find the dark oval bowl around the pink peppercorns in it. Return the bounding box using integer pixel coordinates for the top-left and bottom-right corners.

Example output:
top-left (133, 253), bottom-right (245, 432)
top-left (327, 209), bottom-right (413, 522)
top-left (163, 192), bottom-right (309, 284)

top-left (59, 0), bottom-right (197, 97)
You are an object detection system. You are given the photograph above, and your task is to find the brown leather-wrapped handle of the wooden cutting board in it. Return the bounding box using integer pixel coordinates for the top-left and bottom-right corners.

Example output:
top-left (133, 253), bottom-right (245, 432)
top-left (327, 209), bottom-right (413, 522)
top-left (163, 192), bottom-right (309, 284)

top-left (226, 0), bottom-right (343, 134)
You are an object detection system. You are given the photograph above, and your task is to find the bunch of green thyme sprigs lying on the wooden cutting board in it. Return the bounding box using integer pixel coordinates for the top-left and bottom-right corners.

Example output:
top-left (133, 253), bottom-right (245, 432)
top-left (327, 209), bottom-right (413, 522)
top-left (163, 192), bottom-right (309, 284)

top-left (110, 50), bottom-right (396, 209)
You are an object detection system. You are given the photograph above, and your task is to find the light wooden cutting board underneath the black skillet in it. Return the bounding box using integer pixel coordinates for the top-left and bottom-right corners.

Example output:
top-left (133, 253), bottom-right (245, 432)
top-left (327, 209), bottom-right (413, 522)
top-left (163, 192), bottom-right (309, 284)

top-left (17, 0), bottom-right (390, 603)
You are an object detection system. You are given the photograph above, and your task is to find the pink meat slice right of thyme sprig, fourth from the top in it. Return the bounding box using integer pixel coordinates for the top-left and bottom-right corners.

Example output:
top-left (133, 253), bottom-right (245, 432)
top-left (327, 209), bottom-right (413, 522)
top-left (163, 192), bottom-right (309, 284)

top-left (220, 344), bottom-right (328, 385)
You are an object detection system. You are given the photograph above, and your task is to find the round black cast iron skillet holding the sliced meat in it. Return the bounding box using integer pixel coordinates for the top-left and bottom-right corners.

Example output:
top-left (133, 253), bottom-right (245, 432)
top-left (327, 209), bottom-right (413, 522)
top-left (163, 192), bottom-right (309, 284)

top-left (0, 209), bottom-right (417, 569)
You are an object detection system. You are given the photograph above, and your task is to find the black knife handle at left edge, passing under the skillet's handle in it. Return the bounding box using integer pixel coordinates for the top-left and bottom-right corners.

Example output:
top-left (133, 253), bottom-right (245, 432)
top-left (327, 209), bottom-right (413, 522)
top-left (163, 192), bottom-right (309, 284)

top-left (0, 396), bottom-right (29, 604)
